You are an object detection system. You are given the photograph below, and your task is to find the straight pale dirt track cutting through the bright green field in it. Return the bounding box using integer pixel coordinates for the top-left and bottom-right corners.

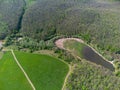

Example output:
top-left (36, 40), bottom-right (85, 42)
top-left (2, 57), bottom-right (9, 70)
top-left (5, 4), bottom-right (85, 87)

top-left (11, 50), bottom-right (36, 90)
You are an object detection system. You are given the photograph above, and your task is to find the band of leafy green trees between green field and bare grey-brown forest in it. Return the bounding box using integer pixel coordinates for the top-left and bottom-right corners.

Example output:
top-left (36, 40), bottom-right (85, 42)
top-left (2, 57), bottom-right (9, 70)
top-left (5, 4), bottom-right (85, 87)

top-left (16, 37), bottom-right (54, 52)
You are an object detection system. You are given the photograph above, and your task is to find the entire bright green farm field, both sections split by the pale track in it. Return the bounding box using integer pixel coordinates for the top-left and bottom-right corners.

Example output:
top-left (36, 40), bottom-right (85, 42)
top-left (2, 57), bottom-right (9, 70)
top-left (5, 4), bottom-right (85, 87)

top-left (0, 51), bottom-right (69, 90)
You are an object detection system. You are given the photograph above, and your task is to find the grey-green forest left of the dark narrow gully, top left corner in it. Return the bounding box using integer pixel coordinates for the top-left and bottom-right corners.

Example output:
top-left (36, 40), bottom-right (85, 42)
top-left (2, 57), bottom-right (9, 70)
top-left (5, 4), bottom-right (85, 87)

top-left (0, 0), bottom-right (25, 39)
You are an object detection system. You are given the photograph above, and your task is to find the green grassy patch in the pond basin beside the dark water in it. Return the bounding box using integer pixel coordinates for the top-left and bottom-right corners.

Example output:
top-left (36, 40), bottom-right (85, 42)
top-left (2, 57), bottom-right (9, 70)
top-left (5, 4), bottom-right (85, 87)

top-left (64, 40), bottom-right (85, 57)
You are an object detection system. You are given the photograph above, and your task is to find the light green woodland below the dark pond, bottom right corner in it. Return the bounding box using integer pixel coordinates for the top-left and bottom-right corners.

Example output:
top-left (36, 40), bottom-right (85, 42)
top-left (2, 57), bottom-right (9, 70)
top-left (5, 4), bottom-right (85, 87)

top-left (66, 61), bottom-right (120, 90)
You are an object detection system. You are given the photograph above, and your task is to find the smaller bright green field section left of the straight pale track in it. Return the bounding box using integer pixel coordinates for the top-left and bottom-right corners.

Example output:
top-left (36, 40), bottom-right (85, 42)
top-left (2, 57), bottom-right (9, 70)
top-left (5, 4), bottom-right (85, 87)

top-left (0, 52), bottom-right (32, 90)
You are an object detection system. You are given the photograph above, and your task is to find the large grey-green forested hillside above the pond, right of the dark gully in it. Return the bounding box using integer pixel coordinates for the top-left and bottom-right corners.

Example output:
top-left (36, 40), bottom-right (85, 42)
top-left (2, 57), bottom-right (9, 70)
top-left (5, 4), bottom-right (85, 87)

top-left (21, 0), bottom-right (120, 52)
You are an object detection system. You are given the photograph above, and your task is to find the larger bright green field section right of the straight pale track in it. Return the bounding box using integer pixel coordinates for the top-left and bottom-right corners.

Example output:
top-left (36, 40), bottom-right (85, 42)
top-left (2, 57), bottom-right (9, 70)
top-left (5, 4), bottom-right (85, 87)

top-left (15, 51), bottom-right (69, 90)
